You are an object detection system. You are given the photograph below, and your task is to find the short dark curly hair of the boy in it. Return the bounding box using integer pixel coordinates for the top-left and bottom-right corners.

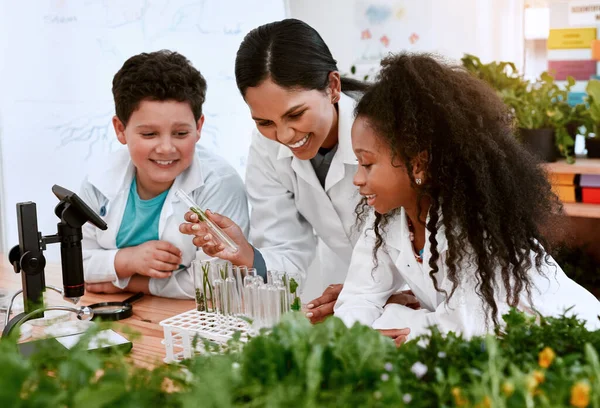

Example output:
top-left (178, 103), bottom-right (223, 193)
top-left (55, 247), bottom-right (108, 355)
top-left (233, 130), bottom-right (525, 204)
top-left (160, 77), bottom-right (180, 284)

top-left (112, 50), bottom-right (206, 125)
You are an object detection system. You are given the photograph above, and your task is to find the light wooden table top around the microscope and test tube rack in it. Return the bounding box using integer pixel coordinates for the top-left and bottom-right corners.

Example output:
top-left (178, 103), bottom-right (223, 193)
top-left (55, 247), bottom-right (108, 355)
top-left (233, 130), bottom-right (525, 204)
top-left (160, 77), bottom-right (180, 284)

top-left (0, 253), bottom-right (194, 367)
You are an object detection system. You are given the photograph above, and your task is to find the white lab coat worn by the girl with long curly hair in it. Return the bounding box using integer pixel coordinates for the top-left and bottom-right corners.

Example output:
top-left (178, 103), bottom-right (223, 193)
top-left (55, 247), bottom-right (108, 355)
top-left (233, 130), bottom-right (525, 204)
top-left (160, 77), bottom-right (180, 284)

top-left (335, 209), bottom-right (600, 338)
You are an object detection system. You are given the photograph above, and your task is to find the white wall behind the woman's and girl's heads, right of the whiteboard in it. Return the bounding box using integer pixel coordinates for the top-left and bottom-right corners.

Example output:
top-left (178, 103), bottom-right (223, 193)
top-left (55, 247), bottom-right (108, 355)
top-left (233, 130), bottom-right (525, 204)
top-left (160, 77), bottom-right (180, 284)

top-left (289, 0), bottom-right (523, 72)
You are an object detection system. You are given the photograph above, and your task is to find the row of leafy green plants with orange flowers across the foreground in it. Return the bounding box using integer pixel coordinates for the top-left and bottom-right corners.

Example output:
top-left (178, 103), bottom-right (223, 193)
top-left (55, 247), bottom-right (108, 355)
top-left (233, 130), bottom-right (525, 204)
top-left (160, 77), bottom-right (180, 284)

top-left (0, 310), bottom-right (600, 408)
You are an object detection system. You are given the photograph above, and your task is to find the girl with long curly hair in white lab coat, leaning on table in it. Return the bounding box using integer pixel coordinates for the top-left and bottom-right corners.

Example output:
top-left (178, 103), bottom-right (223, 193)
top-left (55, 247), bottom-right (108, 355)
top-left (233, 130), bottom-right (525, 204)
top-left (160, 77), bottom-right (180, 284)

top-left (335, 54), bottom-right (600, 337)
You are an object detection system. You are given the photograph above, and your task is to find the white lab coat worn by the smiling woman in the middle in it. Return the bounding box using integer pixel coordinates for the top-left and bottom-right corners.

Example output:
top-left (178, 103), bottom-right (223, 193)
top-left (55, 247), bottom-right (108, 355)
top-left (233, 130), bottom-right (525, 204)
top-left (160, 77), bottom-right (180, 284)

top-left (246, 94), bottom-right (360, 285)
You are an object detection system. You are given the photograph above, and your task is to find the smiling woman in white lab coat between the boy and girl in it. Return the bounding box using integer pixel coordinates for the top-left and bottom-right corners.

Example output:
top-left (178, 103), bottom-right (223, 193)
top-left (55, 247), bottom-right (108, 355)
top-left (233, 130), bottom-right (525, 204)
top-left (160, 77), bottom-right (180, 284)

top-left (181, 19), bottom-right (420, 321)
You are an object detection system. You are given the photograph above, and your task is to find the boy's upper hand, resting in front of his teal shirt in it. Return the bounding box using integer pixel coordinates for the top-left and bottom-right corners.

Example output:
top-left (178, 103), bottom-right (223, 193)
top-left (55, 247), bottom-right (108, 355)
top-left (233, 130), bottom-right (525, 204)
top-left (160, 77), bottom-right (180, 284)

top-left (115, 241), bottom-right (182, 279)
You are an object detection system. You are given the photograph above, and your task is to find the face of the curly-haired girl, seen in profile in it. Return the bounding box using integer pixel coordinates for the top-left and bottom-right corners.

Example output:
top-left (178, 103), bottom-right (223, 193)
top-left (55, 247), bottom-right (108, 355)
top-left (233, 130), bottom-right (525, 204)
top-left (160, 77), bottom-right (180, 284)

top-left (352, 116), bottom-right (422, 214)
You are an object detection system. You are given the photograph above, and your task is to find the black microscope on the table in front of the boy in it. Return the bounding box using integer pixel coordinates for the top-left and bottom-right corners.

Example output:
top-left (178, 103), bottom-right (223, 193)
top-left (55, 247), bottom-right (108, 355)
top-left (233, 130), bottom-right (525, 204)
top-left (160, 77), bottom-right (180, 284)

top-left (2, 185), bottom-right (107, 336)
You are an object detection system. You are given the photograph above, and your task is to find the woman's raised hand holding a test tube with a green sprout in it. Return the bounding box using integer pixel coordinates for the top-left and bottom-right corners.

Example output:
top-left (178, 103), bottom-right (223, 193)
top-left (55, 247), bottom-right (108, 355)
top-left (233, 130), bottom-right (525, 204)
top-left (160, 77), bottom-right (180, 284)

top-left (179, 210), bottom-right (254, 268)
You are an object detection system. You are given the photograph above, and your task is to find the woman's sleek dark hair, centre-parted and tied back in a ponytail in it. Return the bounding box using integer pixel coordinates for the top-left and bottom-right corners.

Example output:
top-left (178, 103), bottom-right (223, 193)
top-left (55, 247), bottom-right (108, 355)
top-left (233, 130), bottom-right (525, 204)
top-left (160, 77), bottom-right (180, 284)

top-left (235, 19), bottom-right (367, 97)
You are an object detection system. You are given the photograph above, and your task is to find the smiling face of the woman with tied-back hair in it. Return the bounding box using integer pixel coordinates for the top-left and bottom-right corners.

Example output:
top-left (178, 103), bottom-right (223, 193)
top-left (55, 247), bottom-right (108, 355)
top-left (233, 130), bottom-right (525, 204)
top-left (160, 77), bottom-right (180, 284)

top-left (245, 72), bottom-right (340, 160)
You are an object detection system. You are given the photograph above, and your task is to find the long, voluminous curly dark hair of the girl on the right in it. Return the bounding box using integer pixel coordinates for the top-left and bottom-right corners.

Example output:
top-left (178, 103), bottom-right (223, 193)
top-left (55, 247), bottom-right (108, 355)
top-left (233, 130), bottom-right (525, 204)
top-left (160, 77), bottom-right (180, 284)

top-left (356, 53), bottom-right (562, 326)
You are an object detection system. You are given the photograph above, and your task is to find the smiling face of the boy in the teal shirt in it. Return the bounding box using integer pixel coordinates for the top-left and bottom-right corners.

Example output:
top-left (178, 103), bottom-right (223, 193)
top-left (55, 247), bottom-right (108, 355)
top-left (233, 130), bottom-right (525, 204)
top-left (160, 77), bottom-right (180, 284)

top-left (113, 100), bottom-right (204, 199)
